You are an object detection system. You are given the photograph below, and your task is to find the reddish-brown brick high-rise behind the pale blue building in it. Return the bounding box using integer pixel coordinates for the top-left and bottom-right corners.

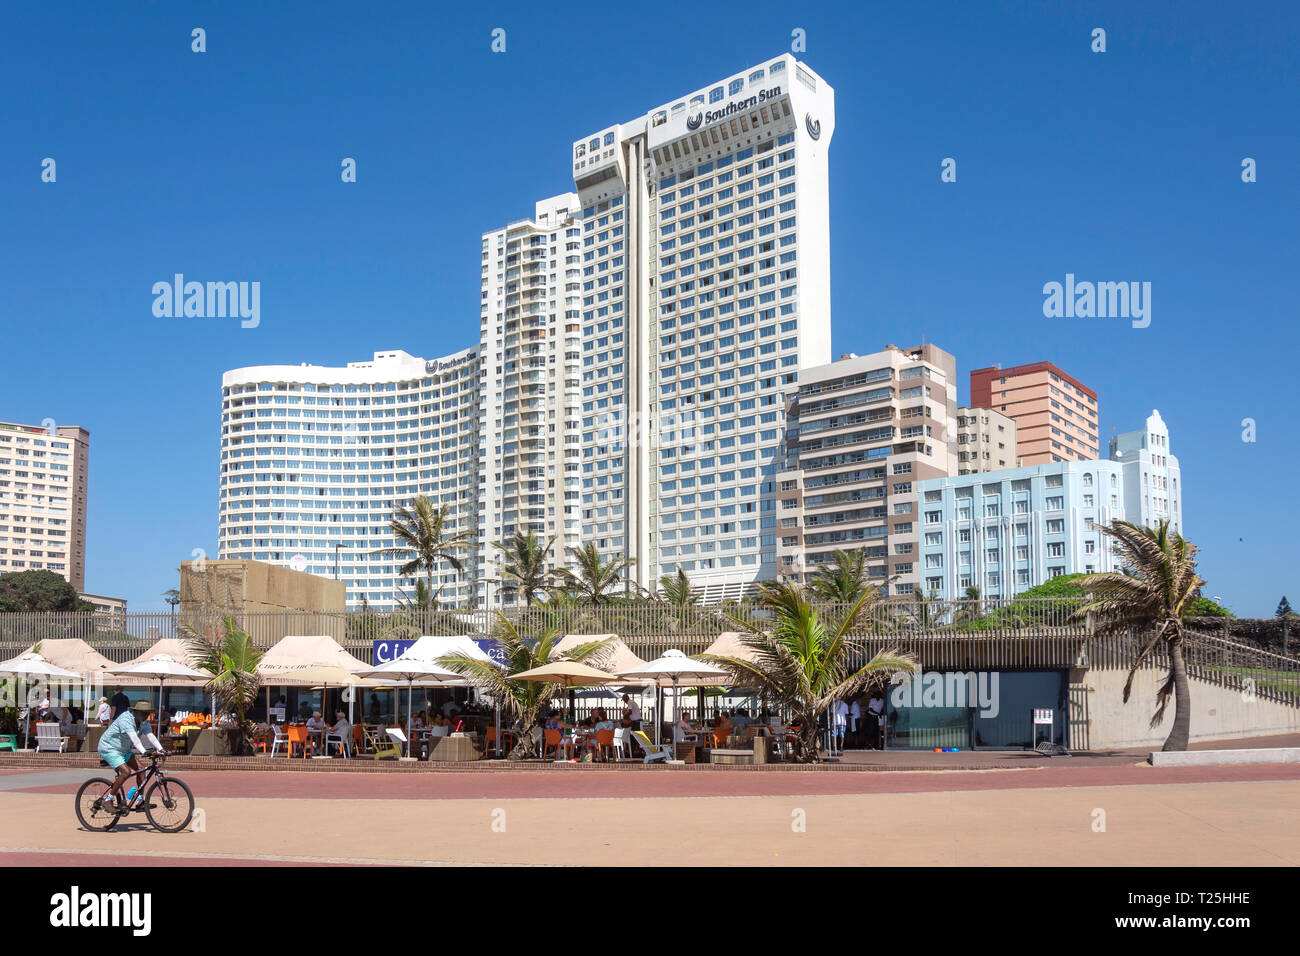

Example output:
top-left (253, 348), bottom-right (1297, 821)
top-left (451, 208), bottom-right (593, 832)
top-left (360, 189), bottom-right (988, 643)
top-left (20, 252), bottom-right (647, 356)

top-left (971, 362), bottom-right (1101, 464)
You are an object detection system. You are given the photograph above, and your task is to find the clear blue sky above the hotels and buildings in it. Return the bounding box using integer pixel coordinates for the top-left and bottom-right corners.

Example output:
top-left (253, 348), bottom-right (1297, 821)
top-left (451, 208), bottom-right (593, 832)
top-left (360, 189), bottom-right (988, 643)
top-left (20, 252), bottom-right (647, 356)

top-left (0, 3), bottom-right (1300, 615)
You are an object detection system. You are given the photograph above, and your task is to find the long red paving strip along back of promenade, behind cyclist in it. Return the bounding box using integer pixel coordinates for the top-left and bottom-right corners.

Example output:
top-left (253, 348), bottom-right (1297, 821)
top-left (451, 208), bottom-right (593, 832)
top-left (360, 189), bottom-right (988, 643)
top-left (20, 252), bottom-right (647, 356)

top-left (7, 763), bottom-right (1300, 800)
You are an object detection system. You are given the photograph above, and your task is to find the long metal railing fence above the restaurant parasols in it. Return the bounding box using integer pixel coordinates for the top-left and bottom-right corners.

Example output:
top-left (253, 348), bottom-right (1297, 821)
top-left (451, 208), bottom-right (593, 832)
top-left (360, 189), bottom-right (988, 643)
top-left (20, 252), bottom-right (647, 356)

top-left (0, 598), bottom-right (1300, 705)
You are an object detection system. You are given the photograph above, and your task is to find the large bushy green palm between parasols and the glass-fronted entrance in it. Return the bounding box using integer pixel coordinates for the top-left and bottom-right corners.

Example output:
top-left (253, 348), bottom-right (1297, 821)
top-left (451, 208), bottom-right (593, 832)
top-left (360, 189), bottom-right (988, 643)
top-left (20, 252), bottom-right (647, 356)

top-left (705, 583), bottom-right (917, 762)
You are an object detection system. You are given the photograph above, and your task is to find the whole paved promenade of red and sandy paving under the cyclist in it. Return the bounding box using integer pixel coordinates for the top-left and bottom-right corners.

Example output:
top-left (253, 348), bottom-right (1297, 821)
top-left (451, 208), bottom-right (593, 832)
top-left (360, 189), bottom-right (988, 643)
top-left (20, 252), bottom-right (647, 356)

top-left (0, 760), bottom-right (1300, 866)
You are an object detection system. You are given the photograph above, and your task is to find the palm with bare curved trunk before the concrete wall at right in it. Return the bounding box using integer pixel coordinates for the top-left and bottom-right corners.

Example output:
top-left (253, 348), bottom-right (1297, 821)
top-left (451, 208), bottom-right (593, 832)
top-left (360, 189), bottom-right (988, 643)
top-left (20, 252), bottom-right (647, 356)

top-left (1075, 520), bottom-right (1205, 750)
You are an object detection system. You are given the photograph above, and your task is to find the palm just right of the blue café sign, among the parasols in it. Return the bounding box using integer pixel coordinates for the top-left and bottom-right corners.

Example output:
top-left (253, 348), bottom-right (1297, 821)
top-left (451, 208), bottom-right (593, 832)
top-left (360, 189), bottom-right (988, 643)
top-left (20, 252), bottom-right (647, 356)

top-left (438, 611), bottom-right (612, 760)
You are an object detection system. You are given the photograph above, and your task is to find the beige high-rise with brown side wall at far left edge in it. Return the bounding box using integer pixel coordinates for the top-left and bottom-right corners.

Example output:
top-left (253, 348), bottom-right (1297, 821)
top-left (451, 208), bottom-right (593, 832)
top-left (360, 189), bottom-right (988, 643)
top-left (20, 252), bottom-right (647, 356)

top-left (0, 421), bottom-right (90, 592)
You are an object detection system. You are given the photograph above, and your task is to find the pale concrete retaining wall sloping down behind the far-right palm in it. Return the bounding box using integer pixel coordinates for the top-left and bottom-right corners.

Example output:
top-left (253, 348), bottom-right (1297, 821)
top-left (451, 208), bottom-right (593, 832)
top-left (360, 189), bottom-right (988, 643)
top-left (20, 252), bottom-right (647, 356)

top-left (1070, 660), bottom-right (1300, 750)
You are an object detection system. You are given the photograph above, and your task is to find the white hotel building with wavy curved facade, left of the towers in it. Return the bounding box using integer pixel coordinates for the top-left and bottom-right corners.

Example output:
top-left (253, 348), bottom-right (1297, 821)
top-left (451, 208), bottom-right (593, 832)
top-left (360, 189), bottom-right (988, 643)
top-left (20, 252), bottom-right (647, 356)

top-left (217, 349), bottom-right (480, 607)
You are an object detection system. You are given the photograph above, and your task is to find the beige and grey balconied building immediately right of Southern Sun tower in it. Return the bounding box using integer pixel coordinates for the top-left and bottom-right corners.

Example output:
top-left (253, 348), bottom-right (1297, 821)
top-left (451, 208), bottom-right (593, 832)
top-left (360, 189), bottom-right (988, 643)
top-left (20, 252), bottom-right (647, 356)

top-left (776, 345), bottom-right (958, 594)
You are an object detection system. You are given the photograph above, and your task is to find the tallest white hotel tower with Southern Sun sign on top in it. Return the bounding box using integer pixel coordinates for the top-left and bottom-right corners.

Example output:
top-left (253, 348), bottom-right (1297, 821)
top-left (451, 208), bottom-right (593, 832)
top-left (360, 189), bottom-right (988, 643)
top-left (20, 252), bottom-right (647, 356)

top-left (573, 55), bottom-right (835, 598)
